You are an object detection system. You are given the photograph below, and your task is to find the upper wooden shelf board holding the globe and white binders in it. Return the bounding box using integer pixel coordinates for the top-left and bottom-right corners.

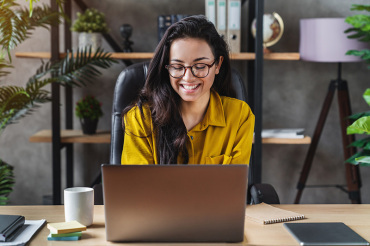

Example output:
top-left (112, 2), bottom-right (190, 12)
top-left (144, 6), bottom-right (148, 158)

top-left (15, 52), bottom-right (300, 61)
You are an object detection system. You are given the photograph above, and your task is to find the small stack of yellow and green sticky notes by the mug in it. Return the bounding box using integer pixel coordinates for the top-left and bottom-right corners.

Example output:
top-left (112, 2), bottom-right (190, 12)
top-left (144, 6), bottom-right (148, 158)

top-left (48, 221), bottom-right (86, 241)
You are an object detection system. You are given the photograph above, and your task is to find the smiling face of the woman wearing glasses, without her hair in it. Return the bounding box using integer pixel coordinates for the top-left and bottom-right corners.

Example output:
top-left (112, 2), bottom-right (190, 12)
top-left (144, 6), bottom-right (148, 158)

top-left (169, 38), bottom-right (223, 103)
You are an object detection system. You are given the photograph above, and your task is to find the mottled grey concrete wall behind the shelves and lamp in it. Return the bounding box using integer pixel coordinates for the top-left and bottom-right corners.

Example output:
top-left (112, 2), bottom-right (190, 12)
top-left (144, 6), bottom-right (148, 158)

top-left (0, 0), bottom-right (370, 205)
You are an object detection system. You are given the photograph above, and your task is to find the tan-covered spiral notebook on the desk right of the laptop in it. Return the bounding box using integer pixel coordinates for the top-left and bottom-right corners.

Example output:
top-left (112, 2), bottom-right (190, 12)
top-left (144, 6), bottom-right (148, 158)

top-left (245, 203), bottom-right (305, 225)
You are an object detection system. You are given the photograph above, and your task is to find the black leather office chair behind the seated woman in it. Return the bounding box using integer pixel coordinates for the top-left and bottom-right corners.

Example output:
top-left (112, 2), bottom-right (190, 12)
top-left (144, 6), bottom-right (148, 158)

top-left (94, 62), bottom-right (280, 204)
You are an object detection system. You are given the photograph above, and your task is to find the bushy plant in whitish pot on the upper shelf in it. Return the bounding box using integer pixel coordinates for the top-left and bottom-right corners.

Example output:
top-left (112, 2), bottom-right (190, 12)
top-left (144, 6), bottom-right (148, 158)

top-left (71, 8), bottom-right (109, 51)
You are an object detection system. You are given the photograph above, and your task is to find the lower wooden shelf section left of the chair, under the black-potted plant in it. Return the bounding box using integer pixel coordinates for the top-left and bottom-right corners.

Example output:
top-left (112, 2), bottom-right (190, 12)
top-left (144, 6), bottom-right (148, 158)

top-left (29, 130), bottom-right (110, 143)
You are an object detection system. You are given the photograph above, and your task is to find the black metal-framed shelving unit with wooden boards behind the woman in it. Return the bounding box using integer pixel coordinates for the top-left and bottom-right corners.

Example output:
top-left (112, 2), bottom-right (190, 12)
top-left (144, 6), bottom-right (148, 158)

top-left (21, 0), bottom-right (311, 204)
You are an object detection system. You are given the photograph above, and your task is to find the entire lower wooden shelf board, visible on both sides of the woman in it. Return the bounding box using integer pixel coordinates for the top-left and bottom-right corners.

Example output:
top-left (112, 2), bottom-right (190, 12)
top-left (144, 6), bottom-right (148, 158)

top-left (29, 130), bottom-right (311, 144)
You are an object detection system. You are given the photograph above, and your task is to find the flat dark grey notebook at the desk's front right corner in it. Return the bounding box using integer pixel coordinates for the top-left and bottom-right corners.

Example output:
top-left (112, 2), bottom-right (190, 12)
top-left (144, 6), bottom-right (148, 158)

top-left (284, 222), bottom-right (369, 246)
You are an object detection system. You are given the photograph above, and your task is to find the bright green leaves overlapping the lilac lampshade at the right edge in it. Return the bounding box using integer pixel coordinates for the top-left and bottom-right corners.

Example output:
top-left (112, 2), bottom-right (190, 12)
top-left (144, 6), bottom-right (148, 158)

top-left (345, 4), bottom-right (370, 64)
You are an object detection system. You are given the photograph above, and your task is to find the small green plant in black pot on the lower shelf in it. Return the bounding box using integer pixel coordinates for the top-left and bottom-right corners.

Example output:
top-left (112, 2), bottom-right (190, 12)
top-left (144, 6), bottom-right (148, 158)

top-left (75, 95), bottom-right (103, 134)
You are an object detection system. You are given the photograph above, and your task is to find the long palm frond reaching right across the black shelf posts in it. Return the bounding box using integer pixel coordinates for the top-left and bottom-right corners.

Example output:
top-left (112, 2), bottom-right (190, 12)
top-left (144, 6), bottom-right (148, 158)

top-left (0, 48), bottom-right (116, 134)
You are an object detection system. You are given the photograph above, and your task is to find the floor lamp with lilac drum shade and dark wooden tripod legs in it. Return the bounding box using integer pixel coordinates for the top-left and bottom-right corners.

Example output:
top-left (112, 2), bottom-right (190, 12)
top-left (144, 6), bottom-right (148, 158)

top-left (295, 18), bottom-right (367, 204)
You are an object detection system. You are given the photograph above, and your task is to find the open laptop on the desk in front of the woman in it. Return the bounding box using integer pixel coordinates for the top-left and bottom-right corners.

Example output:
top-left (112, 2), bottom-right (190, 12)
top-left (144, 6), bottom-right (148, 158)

top-left (102, 164), bottom-right (248, 242)
